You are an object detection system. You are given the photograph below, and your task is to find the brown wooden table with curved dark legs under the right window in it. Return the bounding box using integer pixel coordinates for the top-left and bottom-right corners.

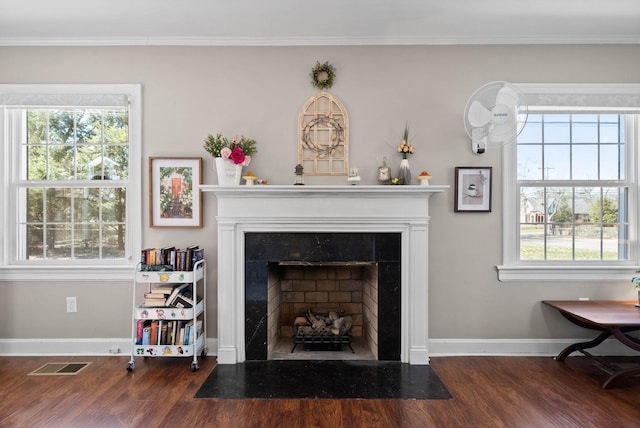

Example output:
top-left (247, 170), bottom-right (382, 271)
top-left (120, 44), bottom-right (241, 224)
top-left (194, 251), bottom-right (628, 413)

top-left (542, 300), bottom-right (640, 389)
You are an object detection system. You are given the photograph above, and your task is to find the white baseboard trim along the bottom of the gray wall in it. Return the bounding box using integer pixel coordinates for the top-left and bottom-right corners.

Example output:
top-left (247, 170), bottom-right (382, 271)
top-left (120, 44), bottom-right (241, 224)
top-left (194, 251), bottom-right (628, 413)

top-left (0, 338), bottom-right (638, 361)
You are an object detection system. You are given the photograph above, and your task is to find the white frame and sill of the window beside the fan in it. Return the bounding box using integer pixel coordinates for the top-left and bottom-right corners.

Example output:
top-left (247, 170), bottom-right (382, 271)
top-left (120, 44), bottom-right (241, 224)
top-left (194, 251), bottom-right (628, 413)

top-left (496, 84), bottom-right (640, 281)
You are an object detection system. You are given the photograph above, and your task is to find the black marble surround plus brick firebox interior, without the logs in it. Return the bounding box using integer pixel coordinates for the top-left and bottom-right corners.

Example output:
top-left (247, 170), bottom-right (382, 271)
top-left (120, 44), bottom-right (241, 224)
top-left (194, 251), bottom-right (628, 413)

top-left (244, 232), bottom-right (401, 361)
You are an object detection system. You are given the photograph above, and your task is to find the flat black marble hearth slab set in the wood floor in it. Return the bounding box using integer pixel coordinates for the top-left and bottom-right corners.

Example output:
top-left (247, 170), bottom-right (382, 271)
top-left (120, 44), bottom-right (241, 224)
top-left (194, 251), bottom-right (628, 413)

top-left (195, 360), bottom-right (453, 400)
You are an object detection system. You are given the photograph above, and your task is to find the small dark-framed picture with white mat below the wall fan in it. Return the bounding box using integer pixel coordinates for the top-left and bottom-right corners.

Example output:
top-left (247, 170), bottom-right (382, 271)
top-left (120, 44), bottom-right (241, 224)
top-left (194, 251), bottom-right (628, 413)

top-left (454, 166), bottom-right (492, 212)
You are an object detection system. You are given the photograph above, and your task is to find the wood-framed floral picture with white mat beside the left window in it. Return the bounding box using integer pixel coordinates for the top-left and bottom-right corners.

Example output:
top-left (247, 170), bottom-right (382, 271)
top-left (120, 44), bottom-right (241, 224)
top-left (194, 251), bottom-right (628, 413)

top-left (149, 157), bottom-right (202, 228)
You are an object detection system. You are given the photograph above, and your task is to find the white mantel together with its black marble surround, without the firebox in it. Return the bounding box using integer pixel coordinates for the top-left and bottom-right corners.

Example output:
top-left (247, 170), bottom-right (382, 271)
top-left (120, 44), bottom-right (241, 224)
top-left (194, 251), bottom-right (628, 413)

top-left (201, 186), bottom-right (448, 364)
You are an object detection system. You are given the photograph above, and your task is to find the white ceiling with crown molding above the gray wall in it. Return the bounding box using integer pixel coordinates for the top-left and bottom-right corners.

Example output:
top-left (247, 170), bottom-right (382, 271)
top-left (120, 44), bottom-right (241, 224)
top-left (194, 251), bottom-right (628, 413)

top-left (0, 0), bottom-right (640, 46)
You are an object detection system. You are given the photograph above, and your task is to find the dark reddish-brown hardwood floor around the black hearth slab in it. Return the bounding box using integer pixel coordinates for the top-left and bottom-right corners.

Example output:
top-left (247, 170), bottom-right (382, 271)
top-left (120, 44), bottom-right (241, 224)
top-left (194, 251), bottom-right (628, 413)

top-left (0, 356), bottom-right (640, 428)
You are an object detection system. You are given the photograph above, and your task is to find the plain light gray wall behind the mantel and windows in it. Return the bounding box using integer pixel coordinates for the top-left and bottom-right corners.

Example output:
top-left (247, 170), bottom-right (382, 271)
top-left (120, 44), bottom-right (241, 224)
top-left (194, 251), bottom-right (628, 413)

top-left (0, 45), bottom-right (640, 350)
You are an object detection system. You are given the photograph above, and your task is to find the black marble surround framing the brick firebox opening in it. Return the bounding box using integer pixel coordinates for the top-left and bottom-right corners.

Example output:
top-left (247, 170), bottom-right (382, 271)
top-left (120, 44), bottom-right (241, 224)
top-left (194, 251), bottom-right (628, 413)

top-left (245, 232), bottom-right (401, 361)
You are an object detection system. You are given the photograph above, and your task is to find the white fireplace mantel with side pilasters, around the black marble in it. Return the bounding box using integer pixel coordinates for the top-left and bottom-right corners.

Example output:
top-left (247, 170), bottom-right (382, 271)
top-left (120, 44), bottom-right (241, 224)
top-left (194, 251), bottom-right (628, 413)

top-left (200, 185), bottom-right (449, 364)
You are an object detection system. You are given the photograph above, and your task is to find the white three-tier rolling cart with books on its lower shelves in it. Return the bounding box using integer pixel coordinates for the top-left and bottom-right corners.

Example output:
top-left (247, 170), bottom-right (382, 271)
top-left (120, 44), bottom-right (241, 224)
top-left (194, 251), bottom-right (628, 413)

top-left (127, 260), bottom-right (207, 371)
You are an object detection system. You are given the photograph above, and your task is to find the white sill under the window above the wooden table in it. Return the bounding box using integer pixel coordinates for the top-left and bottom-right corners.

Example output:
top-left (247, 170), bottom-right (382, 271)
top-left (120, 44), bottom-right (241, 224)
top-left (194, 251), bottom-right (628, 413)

top-left (496, 265), bottom-right (637, 282)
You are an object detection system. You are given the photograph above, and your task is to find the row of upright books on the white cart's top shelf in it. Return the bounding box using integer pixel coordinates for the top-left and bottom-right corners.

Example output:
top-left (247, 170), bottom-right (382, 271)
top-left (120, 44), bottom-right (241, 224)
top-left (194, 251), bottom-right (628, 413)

top-left (140, 245), bottom-right (204, 271)
